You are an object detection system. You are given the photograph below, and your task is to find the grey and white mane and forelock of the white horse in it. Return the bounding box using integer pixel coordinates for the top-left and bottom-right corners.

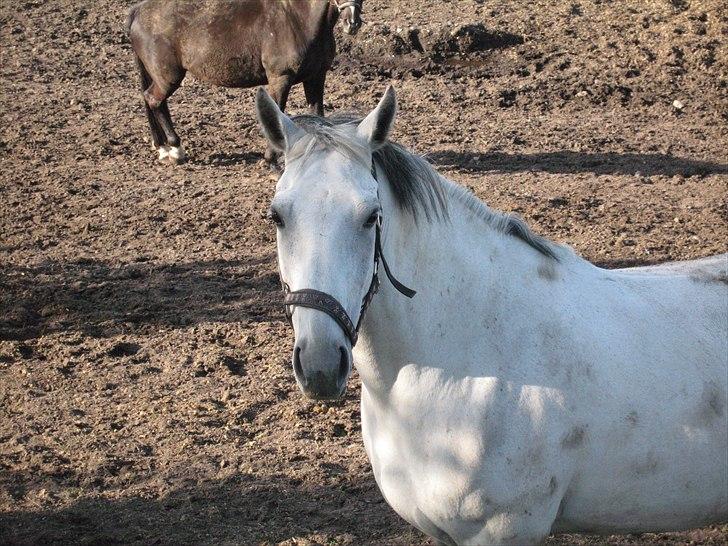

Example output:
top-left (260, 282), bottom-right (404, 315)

top-left (289, 114), bottom-right (558, 260)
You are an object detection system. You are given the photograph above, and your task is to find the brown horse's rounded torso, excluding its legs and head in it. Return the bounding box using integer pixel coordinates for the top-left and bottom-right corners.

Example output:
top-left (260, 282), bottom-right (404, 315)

top-left (132, 0), bottom-right (332, 87)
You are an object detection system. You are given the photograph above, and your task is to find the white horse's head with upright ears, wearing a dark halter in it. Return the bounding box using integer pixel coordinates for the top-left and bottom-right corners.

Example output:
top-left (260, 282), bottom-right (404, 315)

top-left (256, 87), bottom-right (397, 399)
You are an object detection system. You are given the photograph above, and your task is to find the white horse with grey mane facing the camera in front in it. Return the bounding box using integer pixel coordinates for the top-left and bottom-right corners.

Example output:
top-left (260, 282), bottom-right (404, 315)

top-left (257, 88), bottom-right (728, 544)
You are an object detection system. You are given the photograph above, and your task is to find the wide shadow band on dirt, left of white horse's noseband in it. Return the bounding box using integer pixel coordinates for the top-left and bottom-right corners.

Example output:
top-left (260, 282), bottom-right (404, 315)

top-left (0, 254), bottom-right (284, 340)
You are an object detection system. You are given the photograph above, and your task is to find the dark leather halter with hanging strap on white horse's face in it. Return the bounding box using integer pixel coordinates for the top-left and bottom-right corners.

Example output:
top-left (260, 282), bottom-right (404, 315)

top-left (281, 162), bottom-right (417, 347)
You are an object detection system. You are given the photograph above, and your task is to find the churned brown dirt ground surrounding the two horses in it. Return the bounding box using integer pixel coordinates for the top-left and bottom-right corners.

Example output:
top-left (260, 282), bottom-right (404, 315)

top-left (0, 0), bottom-right (728, 545)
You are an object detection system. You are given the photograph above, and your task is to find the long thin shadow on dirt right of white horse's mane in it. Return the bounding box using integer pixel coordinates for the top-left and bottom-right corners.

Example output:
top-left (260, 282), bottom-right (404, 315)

top-left (427, 150), bottom-right (728, 177)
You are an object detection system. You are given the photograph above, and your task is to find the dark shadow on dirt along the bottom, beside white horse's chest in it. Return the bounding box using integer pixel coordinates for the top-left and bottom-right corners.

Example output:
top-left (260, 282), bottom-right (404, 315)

top-left (0, 473), bottom-right (420, 544)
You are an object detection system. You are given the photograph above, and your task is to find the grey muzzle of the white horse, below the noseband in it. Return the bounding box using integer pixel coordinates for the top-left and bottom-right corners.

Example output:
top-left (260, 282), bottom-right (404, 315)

top-left (293, 344), bottom-right (351, 400)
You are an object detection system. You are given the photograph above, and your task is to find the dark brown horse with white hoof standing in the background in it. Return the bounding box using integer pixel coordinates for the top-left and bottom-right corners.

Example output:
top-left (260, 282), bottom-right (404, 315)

top-left (127, 0), bottom-right (362, 163)
